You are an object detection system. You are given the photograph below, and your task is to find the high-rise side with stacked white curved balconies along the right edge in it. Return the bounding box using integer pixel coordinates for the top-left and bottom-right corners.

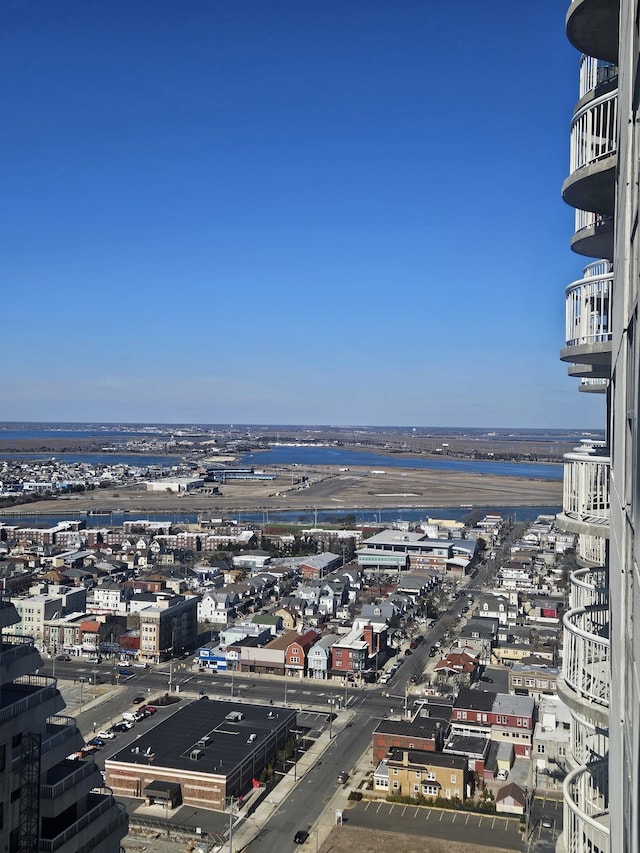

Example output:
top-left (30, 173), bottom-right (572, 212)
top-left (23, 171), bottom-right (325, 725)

top-left (558, 0), bottom-right (640, 853)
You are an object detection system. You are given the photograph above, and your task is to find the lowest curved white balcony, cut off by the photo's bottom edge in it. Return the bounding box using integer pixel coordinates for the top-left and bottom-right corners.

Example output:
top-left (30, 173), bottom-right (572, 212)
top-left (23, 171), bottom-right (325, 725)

top-left (562, 761), bottom-right (609, 853)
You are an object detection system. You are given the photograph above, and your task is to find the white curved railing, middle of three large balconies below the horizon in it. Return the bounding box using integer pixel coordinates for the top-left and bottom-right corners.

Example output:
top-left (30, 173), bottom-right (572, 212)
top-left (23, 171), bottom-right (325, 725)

top-left (562, 605), bottom-right (610, 708)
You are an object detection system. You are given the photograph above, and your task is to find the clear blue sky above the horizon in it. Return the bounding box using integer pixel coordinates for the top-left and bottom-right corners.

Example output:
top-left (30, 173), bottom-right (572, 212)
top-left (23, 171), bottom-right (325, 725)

top-left (0, 0), bottom-right (604, 428)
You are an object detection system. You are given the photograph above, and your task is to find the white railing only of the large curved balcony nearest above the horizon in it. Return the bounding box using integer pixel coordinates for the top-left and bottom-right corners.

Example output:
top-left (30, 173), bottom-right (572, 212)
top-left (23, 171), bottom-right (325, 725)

top-left (566, 261), bottom-right (613, 347)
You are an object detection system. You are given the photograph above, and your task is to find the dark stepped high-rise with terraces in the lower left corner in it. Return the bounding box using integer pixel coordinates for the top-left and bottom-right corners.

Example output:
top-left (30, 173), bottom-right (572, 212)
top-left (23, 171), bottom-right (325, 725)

top-left (0, 599), bottom-right (128, 853)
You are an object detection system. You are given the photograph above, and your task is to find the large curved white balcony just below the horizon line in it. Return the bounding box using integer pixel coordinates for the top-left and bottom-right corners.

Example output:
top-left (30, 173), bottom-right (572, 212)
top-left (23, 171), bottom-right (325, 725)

top-left (557, 440), bottom-right (611, 538)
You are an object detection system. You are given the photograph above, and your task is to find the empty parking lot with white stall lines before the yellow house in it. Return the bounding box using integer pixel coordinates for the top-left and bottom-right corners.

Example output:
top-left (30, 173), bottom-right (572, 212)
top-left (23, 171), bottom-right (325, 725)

top-left (346, 801), bottom-right (524, 850)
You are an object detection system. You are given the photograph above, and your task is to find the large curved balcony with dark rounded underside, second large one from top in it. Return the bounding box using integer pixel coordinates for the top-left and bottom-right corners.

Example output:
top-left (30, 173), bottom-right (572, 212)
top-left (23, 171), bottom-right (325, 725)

top-left (562, 89), bottom-right (618, 216)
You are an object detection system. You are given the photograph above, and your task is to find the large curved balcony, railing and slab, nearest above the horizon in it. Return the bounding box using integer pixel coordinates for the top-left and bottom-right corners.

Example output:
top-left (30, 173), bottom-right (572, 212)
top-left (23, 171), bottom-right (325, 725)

top-left (560, 261), bottom-right (613, 367)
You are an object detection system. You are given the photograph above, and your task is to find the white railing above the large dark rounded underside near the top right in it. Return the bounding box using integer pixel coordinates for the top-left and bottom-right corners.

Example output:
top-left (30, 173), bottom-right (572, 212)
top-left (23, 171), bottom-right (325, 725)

top-left (569, 90), bottom-right (618, 174)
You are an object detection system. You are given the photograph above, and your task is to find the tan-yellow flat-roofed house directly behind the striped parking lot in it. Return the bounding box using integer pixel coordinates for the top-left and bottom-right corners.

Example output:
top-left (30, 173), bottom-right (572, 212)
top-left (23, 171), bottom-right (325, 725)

top-left (373, 747), bottom-right (467, 801)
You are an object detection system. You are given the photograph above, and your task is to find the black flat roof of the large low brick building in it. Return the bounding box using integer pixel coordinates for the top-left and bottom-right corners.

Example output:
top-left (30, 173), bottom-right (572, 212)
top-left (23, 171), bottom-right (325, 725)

top-left (107, 699), bottom-right (297, 776)
